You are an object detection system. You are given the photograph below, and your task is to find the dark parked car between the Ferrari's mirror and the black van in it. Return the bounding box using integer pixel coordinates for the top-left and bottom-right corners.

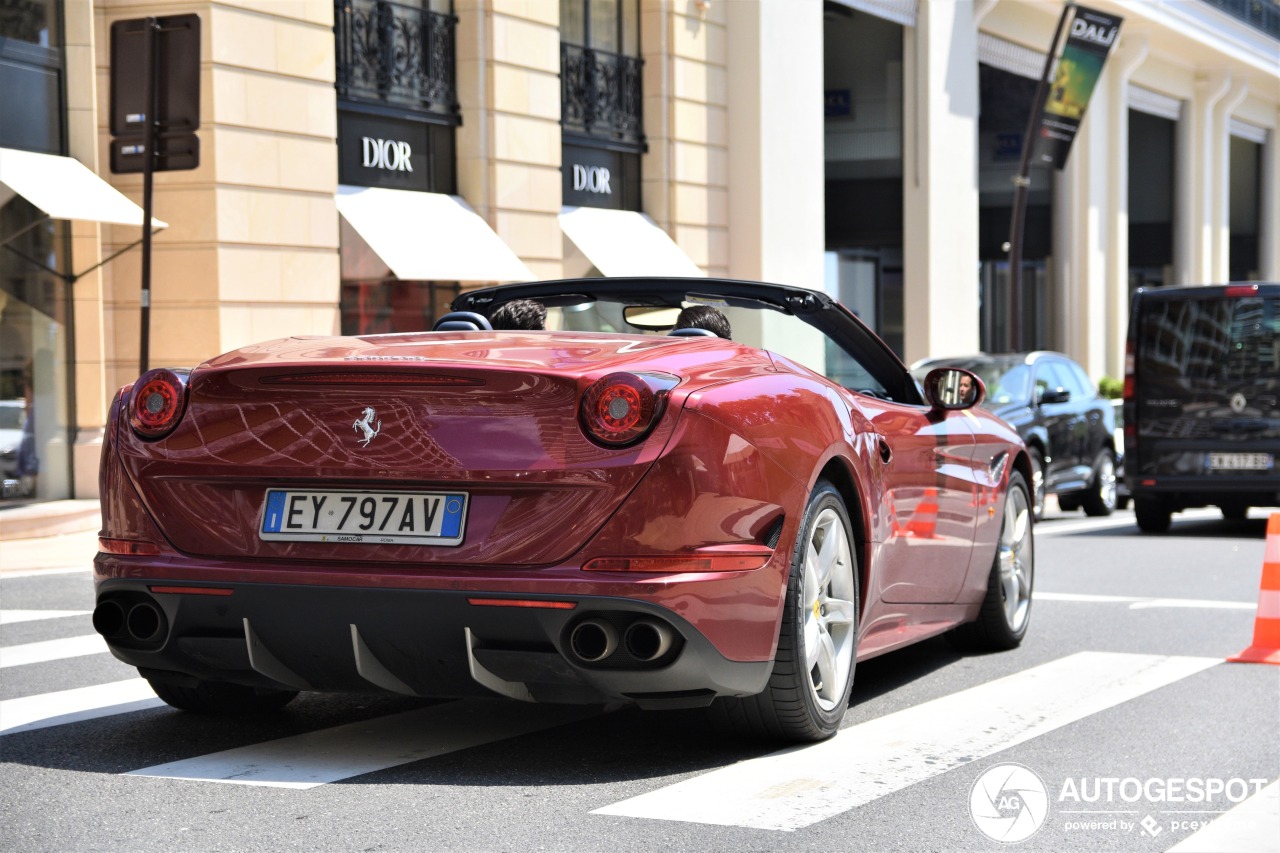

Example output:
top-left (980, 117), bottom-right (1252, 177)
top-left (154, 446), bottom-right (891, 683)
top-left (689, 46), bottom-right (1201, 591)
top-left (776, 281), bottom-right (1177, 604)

top-left (913, 351), bottom-right (1117, 519)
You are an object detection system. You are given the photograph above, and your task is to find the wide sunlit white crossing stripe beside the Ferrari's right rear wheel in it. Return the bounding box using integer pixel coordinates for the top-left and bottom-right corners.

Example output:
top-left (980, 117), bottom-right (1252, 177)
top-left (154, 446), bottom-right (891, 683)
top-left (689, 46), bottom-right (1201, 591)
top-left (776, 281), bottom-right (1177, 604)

top-left (593, 652), bottom-right (1221, 831)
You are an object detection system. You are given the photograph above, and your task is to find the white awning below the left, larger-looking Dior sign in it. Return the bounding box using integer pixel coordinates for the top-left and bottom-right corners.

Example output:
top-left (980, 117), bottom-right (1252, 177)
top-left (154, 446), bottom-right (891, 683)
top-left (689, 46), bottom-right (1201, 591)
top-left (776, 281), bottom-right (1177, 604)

top-left (337, 186), bottom-right (534, 282)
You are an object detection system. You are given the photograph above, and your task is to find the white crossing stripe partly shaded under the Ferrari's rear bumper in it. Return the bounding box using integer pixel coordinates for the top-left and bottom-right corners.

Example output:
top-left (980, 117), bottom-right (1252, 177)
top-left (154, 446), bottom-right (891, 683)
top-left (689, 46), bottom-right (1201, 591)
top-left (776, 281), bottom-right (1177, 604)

top-left (125, 699), bottom-right (599, 788)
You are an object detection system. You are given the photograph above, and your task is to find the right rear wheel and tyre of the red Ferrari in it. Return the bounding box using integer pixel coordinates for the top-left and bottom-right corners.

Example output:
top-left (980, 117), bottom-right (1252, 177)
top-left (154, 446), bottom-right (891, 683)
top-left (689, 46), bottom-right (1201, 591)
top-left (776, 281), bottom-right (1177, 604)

top-left (712, 480), bottom-right (859, 742)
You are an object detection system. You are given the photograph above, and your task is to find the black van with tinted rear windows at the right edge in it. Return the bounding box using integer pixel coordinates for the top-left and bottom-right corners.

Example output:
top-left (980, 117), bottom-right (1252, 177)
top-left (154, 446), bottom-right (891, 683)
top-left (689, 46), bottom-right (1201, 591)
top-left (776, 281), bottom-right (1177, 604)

top-left (1124, 283), bottom-right (1280, 533)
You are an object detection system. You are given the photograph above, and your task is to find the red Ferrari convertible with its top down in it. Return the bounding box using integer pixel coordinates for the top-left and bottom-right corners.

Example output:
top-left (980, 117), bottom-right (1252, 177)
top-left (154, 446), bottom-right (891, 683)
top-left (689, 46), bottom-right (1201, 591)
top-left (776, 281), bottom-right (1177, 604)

top-left (93, 278), bottom-right (1034, 740)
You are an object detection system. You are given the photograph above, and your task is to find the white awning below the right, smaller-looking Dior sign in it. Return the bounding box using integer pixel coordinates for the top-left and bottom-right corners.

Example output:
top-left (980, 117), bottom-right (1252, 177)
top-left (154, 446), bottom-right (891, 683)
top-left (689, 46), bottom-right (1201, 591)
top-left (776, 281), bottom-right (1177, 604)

top-left (559, 207), bottom-right (707, 277)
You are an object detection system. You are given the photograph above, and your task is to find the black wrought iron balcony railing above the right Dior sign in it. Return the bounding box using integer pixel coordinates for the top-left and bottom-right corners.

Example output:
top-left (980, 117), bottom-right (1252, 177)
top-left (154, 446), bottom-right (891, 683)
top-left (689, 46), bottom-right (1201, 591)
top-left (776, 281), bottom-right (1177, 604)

top-left (561, 42), bottom-right (644, 151)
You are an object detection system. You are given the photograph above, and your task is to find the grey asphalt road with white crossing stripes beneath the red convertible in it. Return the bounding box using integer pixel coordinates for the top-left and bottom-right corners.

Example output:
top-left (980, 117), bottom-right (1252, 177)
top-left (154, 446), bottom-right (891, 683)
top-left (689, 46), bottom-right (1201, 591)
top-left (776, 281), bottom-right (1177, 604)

top-left (0, 511), bottom-right (1280, 850)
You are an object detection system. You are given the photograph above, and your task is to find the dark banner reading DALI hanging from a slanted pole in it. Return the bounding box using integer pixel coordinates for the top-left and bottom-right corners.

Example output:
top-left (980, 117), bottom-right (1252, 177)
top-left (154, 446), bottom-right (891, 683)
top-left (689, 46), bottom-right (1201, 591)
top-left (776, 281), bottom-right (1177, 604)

top-left (1036, 5), bottom-right (1124, 169)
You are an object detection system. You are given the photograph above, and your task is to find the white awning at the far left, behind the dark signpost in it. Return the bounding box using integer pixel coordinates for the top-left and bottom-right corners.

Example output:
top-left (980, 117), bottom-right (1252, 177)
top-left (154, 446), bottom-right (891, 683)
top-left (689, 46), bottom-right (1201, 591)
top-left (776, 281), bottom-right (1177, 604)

top-left (0, 149), bottom-right (166, 228)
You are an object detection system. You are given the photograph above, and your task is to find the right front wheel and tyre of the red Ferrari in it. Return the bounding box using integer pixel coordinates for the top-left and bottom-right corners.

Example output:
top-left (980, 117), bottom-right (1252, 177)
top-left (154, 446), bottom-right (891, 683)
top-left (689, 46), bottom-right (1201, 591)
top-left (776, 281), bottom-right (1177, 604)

top-left (947, 471), bottom-right (1036, 652)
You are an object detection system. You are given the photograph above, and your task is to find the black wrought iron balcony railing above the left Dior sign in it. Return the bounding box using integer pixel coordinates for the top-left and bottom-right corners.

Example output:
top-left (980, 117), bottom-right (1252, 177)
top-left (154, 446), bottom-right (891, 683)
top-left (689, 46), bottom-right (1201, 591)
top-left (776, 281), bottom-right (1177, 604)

top-left (334, 0), bottom-right (458, 123)
